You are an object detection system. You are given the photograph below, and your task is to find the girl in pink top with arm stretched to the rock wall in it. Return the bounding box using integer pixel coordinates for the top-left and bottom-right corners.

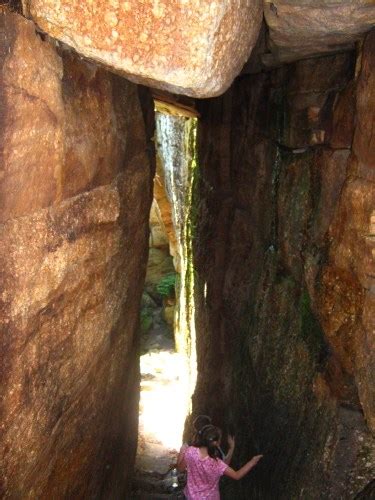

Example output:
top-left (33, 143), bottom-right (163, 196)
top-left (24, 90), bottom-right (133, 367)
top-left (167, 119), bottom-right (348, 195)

top-left (177, 425), bottom-right (262, 500)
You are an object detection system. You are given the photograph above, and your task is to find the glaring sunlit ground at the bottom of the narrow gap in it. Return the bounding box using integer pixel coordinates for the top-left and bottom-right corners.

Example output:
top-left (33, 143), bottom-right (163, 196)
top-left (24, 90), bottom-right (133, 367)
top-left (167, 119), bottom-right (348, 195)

top-left (136, 350), bottom-right (187, 473)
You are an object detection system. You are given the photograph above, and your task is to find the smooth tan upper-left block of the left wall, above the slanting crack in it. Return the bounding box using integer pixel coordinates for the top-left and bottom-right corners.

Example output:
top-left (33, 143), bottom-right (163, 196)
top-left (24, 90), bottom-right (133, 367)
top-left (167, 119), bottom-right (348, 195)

top-left (0, 9), bottom-right (64, 222)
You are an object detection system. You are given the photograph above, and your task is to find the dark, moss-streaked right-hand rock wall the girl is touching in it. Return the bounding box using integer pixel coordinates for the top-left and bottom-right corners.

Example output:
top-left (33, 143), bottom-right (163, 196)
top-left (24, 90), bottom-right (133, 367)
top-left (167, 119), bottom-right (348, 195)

top-left (193, 32), bottom-right (375, 499)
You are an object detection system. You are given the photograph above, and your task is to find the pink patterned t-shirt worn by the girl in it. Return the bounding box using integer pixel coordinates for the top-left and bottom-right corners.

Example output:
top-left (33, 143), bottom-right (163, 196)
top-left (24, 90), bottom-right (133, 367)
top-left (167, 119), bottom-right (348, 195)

top-left (184, 446), bottom-right (228, 500)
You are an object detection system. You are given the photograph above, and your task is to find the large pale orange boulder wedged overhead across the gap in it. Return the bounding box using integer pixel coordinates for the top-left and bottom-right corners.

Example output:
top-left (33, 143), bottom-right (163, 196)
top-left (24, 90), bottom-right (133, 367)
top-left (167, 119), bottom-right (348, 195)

top-left (24, 0), bottom-right (262, 97)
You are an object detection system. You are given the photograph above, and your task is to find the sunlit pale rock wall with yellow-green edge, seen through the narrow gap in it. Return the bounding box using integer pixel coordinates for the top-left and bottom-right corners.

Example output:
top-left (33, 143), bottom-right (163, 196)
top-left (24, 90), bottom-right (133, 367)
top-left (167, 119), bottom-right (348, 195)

top-left (156, 112), bottom-right (197, 415)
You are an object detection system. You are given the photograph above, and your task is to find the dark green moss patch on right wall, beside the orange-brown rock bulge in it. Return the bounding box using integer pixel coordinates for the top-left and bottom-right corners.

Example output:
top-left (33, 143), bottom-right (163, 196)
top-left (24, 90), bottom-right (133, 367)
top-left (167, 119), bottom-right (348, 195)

top-left (299, 290), bottom-right (328, 363)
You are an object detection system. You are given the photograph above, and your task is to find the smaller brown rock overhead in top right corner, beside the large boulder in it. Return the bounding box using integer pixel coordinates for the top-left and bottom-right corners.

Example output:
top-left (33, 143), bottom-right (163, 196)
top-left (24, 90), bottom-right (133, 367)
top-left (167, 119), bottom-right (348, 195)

top-left (263, 0), bottom-right (375, 62)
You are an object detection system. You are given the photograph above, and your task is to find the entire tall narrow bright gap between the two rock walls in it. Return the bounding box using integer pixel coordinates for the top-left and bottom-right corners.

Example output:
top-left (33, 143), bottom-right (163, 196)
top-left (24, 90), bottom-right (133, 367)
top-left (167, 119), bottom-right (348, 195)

top-left (133, 101), bottom-right (197, 497)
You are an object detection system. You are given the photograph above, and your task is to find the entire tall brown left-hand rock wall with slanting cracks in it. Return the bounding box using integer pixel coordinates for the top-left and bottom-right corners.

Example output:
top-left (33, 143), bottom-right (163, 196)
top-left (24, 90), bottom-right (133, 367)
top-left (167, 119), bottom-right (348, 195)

top-left (0, 11), bottom-right (151, 498)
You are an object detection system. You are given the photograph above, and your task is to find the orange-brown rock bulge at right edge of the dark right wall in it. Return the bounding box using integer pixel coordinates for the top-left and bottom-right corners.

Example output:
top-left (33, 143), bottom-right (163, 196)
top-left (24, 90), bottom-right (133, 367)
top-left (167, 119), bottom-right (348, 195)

top-left (321, 172), bottom-right (375, 429)
